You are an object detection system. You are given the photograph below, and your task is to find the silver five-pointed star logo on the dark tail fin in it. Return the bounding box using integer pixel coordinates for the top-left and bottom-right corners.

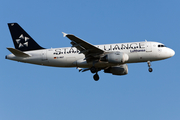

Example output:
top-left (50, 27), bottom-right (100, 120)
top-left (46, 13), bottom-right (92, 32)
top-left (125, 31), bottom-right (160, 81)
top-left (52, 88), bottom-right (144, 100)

top-left (16, 34), bottom-right (29, 48)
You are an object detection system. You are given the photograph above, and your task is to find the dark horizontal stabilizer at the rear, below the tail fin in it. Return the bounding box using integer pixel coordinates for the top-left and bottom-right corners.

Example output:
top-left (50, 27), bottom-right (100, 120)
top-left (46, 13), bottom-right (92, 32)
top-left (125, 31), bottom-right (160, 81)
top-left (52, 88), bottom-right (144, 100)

top-left (7, 48), bottom-right (30, 57)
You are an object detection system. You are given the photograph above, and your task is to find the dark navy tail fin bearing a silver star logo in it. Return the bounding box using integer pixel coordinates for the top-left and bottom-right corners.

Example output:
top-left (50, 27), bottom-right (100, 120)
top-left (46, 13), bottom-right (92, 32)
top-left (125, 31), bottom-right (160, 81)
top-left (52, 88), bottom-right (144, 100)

top-left (8, 23), bottom-right (44, 51)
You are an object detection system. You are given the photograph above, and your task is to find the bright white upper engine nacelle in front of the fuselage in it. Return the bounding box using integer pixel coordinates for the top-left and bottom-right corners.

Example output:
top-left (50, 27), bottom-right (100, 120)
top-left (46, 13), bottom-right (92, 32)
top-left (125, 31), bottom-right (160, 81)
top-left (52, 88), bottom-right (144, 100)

top-left (106, 52), bottom-right (129, 64)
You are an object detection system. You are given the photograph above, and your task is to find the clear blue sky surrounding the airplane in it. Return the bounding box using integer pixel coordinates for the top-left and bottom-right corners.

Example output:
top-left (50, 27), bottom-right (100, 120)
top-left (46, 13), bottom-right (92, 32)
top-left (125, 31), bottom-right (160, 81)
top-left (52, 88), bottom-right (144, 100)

top-left (0, 0), bottom-right (180, 120)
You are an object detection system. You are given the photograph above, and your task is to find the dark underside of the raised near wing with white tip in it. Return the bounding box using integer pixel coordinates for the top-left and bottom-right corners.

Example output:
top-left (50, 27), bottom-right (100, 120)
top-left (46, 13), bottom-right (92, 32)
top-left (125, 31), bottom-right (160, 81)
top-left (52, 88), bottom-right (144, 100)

top-left (63, 33), bottom-right (105, 61)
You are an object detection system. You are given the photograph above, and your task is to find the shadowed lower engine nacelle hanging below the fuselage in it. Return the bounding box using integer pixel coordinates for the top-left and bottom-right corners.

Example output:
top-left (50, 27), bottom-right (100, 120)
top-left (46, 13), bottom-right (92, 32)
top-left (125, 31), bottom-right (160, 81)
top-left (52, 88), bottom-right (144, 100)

top-left (104, 64), bottom-right (128, 75)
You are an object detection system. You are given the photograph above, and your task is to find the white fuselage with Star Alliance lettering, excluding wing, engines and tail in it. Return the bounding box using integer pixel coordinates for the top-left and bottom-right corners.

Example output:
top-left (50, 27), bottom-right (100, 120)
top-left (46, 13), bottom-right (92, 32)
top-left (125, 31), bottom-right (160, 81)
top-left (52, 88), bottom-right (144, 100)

top-left (6, 41), bottom-right (175, 68)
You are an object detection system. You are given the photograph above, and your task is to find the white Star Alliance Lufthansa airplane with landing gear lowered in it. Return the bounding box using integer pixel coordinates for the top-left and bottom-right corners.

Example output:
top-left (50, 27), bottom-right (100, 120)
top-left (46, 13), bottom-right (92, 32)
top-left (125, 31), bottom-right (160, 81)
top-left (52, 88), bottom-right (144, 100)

top-left (5, 23), bottom-right (175, 81)
